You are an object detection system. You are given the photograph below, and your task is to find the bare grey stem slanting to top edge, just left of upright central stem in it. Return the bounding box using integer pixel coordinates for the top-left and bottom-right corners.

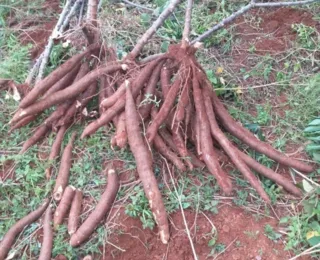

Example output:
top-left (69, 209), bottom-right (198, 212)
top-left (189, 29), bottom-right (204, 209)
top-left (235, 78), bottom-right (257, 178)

top-left (129, 0), bottom-right (181, 59)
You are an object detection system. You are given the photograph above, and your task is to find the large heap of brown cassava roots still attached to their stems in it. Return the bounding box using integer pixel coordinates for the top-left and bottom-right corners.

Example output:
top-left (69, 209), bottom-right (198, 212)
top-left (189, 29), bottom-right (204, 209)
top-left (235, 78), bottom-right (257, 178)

top-left (0, 0), bottom-right (313, 256)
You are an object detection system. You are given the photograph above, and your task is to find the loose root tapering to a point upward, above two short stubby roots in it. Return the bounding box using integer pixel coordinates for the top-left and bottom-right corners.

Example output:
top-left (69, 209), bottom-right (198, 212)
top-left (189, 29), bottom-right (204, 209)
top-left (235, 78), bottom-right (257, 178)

top-left (53, 132), bottom-right (77, 201)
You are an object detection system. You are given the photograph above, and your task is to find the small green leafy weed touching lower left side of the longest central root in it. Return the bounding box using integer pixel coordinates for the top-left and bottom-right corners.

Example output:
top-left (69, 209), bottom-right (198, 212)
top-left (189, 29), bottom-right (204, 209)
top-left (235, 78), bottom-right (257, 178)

top-left (125, 186), bottom-right (155, 229)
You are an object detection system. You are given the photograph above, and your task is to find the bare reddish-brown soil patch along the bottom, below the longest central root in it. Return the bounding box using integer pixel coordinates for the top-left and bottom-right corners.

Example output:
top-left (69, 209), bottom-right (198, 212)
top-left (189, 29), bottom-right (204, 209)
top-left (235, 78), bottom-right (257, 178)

top-left (104, 205), bottom-right (290, 260)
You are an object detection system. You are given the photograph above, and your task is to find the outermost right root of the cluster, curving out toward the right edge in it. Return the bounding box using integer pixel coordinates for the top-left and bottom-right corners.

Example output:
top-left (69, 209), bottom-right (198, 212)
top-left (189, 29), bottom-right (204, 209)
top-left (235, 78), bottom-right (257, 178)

top-left (206, 86), bottom-right (314, 173)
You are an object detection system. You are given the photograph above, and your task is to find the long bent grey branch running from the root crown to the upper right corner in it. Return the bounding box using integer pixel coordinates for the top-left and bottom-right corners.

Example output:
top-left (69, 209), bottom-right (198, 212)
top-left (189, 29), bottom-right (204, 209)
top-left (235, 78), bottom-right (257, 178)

top-left (191, 0), bottom-right (319, 44)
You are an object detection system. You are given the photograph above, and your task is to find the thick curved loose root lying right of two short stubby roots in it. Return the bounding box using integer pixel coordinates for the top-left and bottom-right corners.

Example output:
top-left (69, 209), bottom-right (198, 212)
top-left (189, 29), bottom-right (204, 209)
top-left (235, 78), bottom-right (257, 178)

top-left (70, 169), bottom-right (120, 247)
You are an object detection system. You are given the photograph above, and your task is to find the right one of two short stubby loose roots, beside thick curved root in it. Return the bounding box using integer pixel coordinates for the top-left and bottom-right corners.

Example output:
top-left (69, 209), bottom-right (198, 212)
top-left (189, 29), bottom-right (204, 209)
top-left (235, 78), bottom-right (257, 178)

top-left (68, 190), bottom-right (83, 235)
